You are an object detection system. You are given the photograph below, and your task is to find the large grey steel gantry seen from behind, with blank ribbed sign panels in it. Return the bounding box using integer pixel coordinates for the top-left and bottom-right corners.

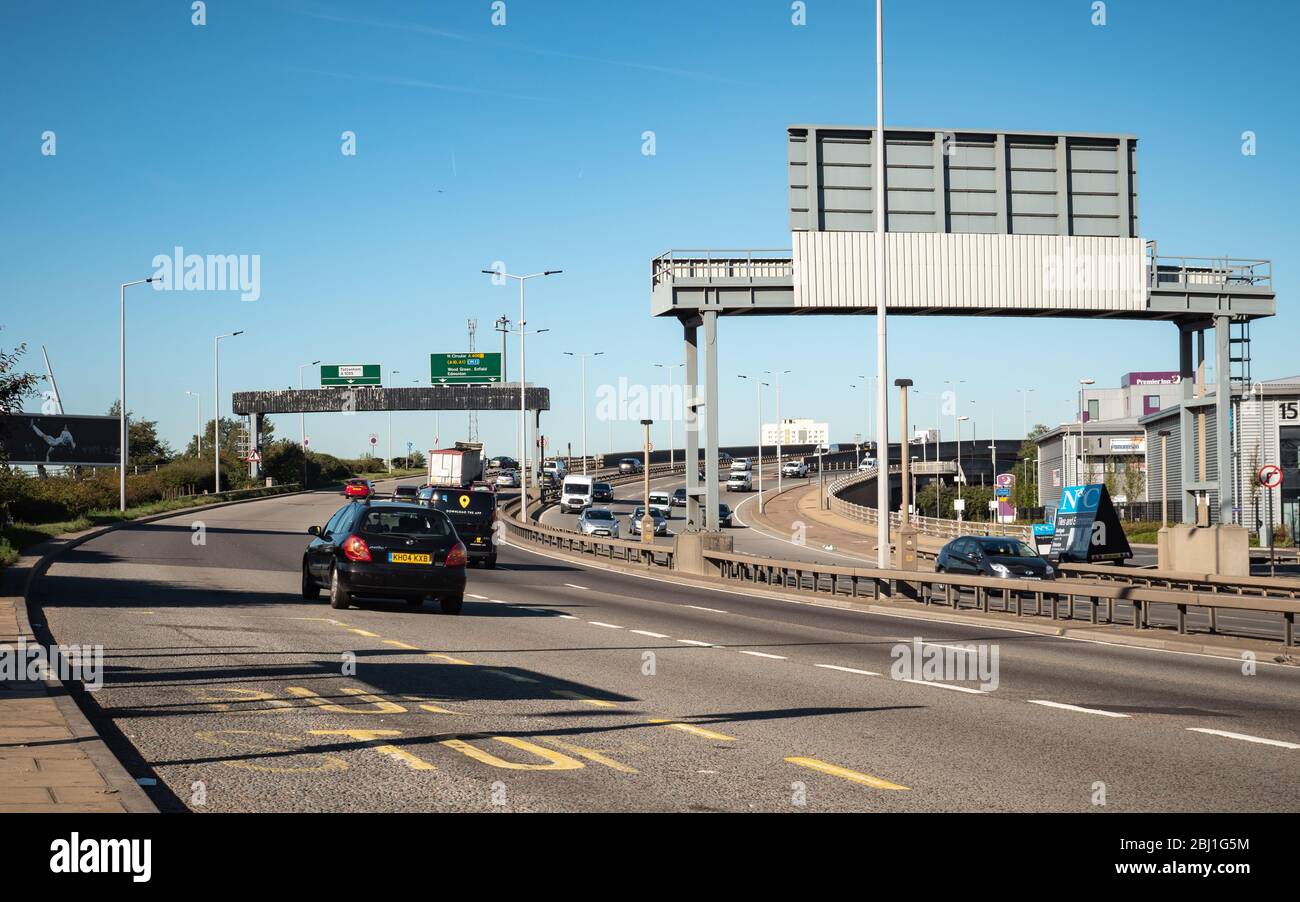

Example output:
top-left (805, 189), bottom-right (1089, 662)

top-left (650, 125), bottom-right (1275, 540)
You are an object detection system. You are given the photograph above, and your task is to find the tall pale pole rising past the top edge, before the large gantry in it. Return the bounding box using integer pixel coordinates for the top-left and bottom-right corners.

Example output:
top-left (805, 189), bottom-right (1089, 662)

top-left (871, 0), bottom-right (889, 569)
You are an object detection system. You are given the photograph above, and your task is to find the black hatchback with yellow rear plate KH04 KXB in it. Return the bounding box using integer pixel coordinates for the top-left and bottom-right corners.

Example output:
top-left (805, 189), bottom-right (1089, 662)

top-left (303, 502), bottom-right (467, 613)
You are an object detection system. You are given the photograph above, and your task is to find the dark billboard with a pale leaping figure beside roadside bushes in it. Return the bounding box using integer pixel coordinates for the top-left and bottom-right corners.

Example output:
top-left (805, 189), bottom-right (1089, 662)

top-left (0, 413), bottom-right (121, 467)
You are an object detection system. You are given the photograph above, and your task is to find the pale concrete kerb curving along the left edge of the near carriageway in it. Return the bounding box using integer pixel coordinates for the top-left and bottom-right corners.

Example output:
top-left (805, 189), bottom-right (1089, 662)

top-left (4, 489), bottom-right (340, 814)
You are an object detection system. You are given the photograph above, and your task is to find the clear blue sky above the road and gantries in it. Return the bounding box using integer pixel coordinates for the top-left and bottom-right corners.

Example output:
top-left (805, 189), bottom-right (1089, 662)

top-left (0, 0), bottom-right (1300, 455)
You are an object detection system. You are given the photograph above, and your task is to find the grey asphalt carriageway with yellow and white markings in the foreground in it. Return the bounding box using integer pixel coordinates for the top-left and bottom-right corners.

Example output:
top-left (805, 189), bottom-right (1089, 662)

top-left (31, 483), bottom-right (1300, 811)
